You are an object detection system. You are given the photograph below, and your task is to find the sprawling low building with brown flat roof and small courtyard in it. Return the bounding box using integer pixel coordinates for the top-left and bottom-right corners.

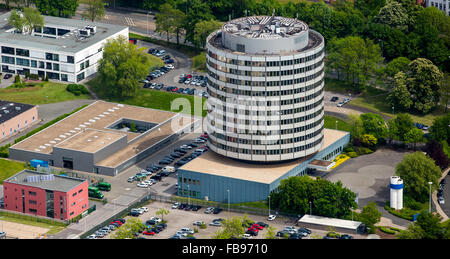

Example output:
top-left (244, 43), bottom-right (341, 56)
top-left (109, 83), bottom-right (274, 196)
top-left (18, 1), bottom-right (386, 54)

top-left (9, 101), bottom-right (194, 176)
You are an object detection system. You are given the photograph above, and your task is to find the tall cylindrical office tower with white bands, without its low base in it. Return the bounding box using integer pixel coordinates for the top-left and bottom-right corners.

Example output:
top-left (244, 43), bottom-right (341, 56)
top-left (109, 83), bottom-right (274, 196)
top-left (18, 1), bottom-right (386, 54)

top-left (206, 16), bottom-right (325, 162)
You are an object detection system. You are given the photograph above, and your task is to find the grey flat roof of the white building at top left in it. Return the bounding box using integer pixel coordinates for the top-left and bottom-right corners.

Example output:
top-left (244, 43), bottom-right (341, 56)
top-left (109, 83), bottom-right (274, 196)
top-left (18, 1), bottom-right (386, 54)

top-left (0, 12), bottom-right (128, 53)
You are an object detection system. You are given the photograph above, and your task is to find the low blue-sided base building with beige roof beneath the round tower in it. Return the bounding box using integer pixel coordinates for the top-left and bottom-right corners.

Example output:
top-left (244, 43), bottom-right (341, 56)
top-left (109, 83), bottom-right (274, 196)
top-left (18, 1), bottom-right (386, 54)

top-left (178, 129), bottom-right (350, 203)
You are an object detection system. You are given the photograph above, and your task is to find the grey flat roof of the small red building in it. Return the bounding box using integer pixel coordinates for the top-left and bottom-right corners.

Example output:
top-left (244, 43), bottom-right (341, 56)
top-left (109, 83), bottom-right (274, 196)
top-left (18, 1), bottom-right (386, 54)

top-left (5, 170), bottom-right (87, 192)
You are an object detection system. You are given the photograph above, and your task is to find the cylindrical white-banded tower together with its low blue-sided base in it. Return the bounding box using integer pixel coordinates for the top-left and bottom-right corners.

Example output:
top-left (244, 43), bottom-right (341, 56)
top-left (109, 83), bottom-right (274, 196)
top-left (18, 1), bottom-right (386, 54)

top-left (178, 16), bottom-right (350, 203)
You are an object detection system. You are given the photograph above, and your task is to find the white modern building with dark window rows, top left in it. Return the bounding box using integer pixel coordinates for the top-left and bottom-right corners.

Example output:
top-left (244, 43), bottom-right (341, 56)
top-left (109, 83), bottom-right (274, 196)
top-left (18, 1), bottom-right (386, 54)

top-left (0, 12), bottom-right (128, 83)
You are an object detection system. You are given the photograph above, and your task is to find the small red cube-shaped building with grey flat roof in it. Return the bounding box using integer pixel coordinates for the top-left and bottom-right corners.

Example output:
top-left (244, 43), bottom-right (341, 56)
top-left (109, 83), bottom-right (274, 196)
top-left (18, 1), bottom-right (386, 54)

top-left (3, 170), bottom-right (89, 220)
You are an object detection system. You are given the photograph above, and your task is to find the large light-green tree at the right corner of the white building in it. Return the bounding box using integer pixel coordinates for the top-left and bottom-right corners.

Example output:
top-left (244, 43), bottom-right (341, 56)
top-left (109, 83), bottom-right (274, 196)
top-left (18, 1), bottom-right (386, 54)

top-left (97, 36), bottom-right (150, 98)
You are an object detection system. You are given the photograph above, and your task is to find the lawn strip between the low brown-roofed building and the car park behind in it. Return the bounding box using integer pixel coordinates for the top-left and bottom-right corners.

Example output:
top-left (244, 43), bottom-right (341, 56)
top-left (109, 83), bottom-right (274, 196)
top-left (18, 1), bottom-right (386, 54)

top-left (87, 78), bottom-right (206, 116)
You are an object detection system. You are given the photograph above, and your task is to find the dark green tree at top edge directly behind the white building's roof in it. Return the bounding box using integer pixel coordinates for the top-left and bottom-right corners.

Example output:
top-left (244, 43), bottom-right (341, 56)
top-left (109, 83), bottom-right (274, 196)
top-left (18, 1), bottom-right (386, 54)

top-left (34, 0), bottom-right (78, 18)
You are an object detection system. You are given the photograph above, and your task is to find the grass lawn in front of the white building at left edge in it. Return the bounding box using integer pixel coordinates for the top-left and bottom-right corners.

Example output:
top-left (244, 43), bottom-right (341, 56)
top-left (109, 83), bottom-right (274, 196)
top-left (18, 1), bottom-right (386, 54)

top-left (0, 82), bottom-right (91, 105)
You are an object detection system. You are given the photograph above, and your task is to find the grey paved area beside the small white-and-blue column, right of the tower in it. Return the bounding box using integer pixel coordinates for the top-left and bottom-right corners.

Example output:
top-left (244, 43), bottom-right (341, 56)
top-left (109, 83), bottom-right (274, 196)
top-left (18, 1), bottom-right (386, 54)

top-left (322, 149), bottom-right (410, 226)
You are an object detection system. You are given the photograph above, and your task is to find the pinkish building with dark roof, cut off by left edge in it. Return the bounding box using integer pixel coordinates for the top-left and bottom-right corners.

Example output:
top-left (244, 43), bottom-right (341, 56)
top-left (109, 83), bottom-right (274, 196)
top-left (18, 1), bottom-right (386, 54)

top-left (0, 100), bottom-right (38, 142)
